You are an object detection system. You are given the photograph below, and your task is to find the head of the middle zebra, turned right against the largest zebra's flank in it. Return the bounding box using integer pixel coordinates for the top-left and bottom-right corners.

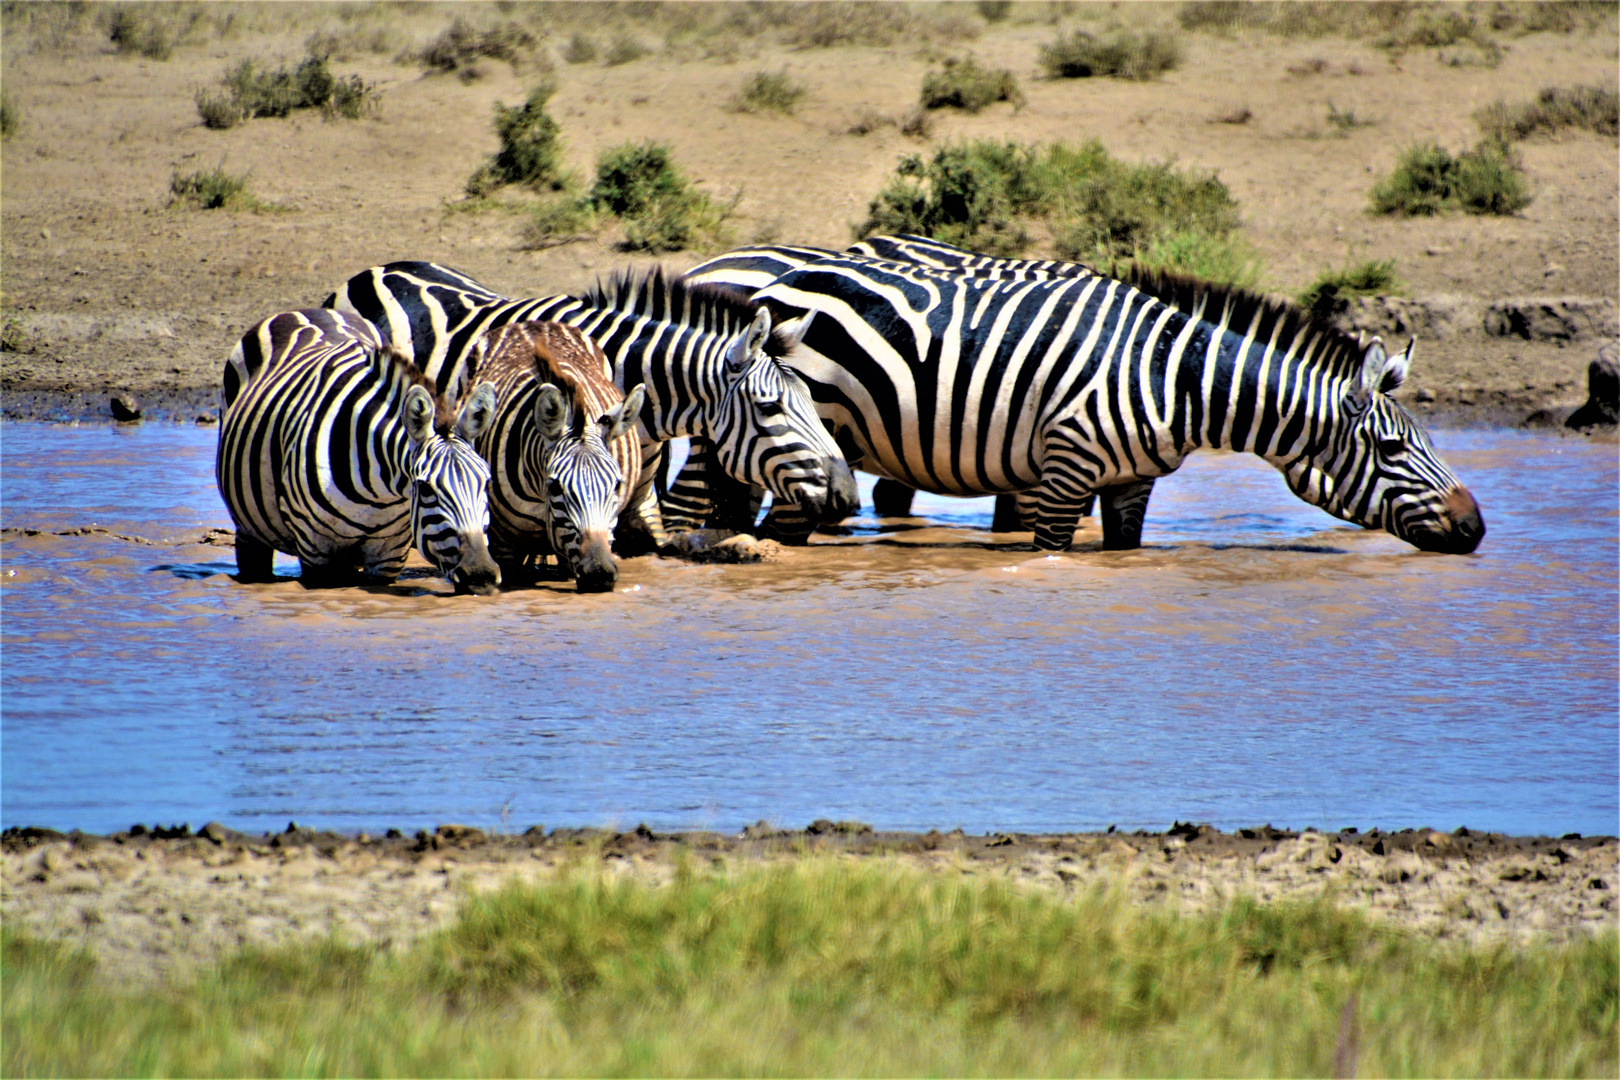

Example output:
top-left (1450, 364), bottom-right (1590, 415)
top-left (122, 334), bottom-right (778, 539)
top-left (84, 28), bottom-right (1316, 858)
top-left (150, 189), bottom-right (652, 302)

top-left (708, 304), bottom-right (859, 523)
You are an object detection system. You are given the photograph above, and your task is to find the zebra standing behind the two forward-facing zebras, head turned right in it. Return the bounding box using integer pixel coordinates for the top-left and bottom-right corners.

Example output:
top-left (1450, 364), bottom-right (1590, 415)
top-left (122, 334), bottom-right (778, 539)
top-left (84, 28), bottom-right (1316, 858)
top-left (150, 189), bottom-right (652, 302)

top-left (327, 262), bottom-right (859, 547)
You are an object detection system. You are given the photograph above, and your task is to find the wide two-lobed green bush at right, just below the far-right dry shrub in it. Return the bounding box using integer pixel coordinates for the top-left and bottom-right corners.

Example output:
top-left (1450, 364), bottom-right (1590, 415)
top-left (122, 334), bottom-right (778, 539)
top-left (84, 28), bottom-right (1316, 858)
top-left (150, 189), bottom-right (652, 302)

top-left (1371, 142), bottom-right (1531, 217)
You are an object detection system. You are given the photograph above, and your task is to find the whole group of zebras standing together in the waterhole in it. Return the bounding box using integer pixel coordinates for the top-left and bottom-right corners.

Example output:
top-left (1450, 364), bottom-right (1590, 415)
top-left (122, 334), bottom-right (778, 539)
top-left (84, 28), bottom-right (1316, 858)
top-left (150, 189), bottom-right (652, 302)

top-left (215, 236), bottom-right (1484, 593)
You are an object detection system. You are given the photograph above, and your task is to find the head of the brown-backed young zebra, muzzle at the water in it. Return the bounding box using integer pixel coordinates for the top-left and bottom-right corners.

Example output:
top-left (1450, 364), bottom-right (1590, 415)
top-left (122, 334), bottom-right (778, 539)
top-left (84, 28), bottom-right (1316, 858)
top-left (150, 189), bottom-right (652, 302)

top-left (535, 382), bottom-right (646, 593)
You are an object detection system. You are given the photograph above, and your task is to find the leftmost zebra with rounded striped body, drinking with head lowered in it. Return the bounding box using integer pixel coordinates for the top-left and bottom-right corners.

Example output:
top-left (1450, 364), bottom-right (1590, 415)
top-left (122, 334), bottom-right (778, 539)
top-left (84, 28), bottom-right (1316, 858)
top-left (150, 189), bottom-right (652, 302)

top-left (214, 309), bottom-right (501, 594)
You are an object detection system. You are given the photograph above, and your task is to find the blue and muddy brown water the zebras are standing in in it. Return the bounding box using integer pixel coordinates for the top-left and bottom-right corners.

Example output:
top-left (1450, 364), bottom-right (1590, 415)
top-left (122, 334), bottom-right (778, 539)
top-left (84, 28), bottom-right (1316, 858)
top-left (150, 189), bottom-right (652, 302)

top-left (0, 423), bottom-right (1620, 836)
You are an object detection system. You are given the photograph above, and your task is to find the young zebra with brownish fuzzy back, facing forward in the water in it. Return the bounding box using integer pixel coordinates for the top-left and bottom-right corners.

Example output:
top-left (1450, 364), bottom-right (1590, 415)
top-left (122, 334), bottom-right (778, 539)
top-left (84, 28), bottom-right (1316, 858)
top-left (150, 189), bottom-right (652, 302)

top-left (475, 322), bottom-right (646, 593)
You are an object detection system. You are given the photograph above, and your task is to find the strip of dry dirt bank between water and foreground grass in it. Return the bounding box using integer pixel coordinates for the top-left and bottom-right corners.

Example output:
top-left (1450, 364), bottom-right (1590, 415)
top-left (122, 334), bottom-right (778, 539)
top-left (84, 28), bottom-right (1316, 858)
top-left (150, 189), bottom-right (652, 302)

top-left (0, 821), bottom-right (1620, 976)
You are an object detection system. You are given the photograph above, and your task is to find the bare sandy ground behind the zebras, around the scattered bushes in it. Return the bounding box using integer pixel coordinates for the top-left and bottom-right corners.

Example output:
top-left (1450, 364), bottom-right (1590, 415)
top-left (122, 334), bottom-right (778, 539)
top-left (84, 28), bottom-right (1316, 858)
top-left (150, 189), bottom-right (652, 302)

top-left (0, 5), bottom-right (1620, 423)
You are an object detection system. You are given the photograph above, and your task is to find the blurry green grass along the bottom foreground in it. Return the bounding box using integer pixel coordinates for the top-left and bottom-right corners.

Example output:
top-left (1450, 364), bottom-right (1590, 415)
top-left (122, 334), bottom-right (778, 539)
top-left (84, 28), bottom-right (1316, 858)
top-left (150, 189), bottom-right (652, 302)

top-left (0, 858), bottom-right (1620, 1075)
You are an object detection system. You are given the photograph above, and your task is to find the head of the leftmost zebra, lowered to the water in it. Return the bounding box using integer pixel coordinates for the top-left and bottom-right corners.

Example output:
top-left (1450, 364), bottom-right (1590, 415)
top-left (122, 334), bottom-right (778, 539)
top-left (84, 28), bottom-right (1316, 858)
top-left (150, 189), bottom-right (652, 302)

top-left (405, 382), bottom-right (501, 596)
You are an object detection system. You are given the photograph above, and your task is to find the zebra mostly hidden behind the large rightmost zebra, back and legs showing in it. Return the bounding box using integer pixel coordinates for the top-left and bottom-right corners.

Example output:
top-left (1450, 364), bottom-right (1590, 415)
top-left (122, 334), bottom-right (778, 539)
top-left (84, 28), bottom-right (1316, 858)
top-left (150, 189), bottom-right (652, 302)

top-left (663, 233), bottom-right (1097, 534)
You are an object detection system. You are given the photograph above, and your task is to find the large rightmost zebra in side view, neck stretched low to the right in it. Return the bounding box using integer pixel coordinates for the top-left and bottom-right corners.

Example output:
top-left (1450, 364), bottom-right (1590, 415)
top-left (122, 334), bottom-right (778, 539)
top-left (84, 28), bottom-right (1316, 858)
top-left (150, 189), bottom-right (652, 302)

top-left (677, 256), bottom-right (1484, 552)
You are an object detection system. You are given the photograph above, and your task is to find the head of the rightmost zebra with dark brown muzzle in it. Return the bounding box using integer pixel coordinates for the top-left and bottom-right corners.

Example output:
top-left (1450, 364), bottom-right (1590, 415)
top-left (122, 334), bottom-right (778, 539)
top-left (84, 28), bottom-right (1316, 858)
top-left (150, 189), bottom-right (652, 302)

top-left (1283, 338), bottom-right (1486, 555)
